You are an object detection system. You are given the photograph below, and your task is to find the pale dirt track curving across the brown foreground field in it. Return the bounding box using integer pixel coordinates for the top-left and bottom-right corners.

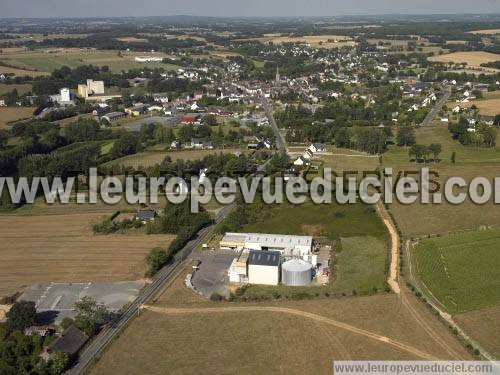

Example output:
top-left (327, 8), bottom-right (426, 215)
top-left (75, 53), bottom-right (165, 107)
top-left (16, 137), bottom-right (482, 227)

top-left (142, 305), bottom-right (438, 360)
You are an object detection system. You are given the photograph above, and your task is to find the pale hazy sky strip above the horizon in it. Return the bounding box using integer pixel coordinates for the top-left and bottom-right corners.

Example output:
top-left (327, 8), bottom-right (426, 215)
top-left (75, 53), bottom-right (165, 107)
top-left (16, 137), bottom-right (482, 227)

top-left (0, 0), bottom-right (500, 17)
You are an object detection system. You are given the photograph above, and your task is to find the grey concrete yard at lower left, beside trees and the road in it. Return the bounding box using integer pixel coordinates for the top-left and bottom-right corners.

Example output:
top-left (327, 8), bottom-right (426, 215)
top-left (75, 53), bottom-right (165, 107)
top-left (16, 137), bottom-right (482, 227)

top-left (21, 281), bottom-right (145, 323)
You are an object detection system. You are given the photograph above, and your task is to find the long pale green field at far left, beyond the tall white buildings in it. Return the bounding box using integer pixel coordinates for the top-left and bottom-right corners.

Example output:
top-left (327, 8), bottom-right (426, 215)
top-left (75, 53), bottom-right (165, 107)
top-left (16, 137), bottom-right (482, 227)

top-left (0, 50), bottom-right (178, 73)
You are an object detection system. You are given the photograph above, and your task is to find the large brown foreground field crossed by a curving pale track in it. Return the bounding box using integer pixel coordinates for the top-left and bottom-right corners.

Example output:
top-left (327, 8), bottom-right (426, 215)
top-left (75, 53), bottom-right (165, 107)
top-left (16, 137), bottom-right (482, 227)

top-left (90, 273), bottom-right (470, 374)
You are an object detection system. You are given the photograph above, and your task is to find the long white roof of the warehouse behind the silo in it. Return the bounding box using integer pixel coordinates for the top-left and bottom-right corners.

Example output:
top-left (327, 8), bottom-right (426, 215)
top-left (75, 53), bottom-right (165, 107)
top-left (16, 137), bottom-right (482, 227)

top-left (222, 233), bottom-right (312, 248)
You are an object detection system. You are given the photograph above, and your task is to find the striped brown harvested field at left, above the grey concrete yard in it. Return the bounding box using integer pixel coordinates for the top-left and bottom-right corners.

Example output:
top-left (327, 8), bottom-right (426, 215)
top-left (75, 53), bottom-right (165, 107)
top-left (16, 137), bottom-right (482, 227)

top-left (0, 214), bottom-right (174, 296)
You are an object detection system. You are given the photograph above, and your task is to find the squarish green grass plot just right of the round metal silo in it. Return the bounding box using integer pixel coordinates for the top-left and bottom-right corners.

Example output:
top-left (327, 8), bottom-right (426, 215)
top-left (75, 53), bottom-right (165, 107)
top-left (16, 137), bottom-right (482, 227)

top-left (332, 236), bottom-right (388, 292)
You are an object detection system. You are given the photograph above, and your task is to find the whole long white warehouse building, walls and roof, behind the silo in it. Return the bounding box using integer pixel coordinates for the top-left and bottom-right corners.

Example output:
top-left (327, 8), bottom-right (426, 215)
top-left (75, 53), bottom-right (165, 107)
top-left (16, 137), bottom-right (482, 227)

top-left (220, 233), bottom-right (313, 257)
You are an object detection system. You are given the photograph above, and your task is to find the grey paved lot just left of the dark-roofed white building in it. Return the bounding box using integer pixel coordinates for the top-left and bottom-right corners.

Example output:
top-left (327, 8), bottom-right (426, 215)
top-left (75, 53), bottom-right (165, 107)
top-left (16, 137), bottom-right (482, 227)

top-left (192, 250), bottom-right (238, 297)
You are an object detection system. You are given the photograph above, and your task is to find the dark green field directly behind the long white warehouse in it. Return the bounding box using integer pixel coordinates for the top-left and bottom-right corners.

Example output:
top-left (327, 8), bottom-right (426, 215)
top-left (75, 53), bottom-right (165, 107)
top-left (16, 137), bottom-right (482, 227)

top-left (242, 201), bottom-right (386, 239)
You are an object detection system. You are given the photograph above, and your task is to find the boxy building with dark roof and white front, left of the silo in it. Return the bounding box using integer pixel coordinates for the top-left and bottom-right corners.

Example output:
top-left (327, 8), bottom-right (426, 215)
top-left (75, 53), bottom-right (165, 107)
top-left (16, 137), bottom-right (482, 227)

top-left (248, 250), bottom-right (281, 285)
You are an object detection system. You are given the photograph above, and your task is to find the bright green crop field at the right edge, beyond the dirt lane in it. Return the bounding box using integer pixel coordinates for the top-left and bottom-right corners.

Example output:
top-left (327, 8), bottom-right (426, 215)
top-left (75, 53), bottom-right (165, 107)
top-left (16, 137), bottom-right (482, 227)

top-left (415, 229), bottom-right (500, 313)
